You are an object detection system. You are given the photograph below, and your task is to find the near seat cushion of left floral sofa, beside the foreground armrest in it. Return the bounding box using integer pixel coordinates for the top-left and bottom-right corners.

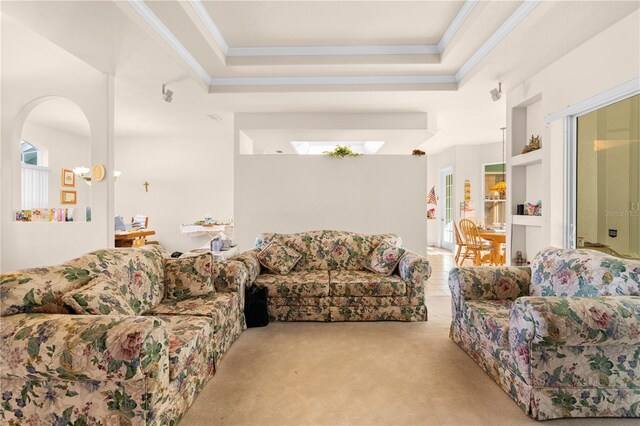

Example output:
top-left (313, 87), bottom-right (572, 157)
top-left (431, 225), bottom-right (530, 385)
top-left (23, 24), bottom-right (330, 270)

top-left (158, 315), bottom-right (213, 380)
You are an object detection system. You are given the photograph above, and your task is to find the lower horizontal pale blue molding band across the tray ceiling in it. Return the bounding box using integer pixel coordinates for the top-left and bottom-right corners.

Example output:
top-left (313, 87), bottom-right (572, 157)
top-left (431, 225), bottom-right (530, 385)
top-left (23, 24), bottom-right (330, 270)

top-left (211, 75), bottom-right (456, 86)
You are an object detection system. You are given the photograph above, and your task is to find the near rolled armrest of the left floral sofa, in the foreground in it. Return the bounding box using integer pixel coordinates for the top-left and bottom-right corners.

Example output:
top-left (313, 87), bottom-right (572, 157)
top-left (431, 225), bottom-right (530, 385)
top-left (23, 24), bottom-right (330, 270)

top-left (0, 314), bottom-right (169, 382)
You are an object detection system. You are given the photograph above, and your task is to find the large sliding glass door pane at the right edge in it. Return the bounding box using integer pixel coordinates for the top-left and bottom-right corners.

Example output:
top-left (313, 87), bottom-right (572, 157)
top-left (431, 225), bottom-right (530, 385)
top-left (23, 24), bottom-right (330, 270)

top-left (574, 95), bottom-right (640, 259)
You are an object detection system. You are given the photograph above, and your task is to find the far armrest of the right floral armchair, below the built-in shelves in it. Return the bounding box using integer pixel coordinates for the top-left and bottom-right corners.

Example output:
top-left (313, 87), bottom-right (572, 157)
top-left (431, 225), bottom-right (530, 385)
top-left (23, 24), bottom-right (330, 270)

top-left (449, 266), bottom-right (531, 319)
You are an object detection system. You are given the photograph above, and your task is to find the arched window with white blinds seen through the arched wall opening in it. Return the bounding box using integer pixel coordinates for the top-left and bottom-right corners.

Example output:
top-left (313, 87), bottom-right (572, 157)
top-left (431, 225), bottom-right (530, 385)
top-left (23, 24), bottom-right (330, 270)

top-left (20, 140), bottom-right (49, 210)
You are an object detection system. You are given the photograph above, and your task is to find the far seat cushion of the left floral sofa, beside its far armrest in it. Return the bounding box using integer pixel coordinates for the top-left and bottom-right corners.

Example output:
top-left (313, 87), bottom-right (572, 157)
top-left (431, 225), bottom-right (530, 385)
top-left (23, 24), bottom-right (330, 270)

top-left (145, 293), bottom-right (240, 333)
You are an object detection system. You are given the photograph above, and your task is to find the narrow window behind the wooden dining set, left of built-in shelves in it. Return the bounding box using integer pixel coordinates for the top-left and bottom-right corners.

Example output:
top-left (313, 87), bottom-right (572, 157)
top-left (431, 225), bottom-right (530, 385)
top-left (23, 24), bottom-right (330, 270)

top-left (482, 163), bottom-right (507, 228)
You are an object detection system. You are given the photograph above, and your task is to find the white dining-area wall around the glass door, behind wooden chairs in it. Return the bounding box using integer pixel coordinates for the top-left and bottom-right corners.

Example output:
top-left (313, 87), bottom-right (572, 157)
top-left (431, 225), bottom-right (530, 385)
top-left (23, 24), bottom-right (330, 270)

top-left (427, 142), bottom-right (503, 246)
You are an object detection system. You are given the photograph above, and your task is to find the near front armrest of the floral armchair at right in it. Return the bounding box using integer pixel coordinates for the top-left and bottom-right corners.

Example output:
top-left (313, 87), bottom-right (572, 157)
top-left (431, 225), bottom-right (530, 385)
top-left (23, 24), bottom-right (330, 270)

top-left (509, 296), bottom-right (640, 350)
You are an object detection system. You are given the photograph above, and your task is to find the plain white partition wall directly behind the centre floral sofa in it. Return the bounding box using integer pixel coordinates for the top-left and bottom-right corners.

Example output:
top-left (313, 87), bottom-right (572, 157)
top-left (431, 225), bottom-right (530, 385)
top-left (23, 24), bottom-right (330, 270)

top-left (235, 155), bottom-right (427, 255)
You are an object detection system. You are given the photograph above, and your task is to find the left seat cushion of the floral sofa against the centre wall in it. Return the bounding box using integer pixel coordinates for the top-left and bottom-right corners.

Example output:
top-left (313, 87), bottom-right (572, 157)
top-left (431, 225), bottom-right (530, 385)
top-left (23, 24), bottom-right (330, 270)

top-left (255, 271), bottom-right (329, 297)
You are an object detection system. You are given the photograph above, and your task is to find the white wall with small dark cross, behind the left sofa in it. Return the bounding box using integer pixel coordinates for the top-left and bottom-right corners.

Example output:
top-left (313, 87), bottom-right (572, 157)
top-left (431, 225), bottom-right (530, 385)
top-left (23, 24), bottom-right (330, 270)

top-left (115, 135), bottom-right (233, 252)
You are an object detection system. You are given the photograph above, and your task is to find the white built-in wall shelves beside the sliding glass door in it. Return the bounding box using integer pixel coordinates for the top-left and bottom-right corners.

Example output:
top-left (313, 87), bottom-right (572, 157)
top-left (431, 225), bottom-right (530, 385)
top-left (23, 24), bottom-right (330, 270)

top-left (507, 94), bottom-right (549, 264)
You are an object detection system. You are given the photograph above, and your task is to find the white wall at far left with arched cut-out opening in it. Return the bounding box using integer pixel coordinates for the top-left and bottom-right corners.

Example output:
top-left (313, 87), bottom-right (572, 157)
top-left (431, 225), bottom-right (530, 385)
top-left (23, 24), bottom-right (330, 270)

top-left (0, 14), bottom-right (113, 272)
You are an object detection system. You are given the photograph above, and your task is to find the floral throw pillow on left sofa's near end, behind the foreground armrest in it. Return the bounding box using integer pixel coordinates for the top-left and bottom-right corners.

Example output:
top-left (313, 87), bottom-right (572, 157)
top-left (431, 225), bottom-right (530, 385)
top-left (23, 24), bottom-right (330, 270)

top-left (62, 276), bottom-right (136, 315)
